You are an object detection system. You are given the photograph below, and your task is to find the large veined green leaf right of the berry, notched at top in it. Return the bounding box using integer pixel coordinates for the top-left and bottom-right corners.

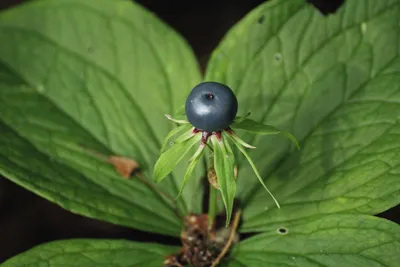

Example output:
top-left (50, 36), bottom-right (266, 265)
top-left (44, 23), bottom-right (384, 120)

top-left (207, 0), bottom-right (400, 231)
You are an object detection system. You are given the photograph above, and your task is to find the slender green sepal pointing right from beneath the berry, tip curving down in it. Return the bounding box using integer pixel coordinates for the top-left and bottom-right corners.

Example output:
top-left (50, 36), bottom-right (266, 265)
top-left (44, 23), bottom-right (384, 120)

top-left (231, 119), bottom-right (300, 149)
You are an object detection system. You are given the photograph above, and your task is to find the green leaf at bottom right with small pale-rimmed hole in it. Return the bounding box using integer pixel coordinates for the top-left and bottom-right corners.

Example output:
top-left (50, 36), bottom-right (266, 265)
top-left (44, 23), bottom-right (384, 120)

top-left (228, 215), bottom-right (400, 267)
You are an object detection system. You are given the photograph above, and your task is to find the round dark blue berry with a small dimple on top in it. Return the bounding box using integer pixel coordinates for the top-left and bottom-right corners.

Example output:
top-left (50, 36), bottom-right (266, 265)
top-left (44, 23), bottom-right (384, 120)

top-left (185, 82), bottom-right (238, 132)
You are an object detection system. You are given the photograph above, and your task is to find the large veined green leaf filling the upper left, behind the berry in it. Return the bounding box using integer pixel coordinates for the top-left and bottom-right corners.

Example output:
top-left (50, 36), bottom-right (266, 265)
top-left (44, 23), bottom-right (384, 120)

top-left (0, 0), bottom-right (201, 237)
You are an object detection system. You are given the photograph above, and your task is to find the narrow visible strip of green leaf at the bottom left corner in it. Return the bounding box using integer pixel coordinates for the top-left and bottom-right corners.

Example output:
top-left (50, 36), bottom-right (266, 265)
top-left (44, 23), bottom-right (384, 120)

top-left (1, 239), bottom-right (179, 267)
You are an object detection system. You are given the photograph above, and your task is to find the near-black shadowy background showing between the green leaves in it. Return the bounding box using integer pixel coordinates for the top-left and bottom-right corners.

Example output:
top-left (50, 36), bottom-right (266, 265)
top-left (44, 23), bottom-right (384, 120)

top-left (0, 0), bottom-right (400, 263)
